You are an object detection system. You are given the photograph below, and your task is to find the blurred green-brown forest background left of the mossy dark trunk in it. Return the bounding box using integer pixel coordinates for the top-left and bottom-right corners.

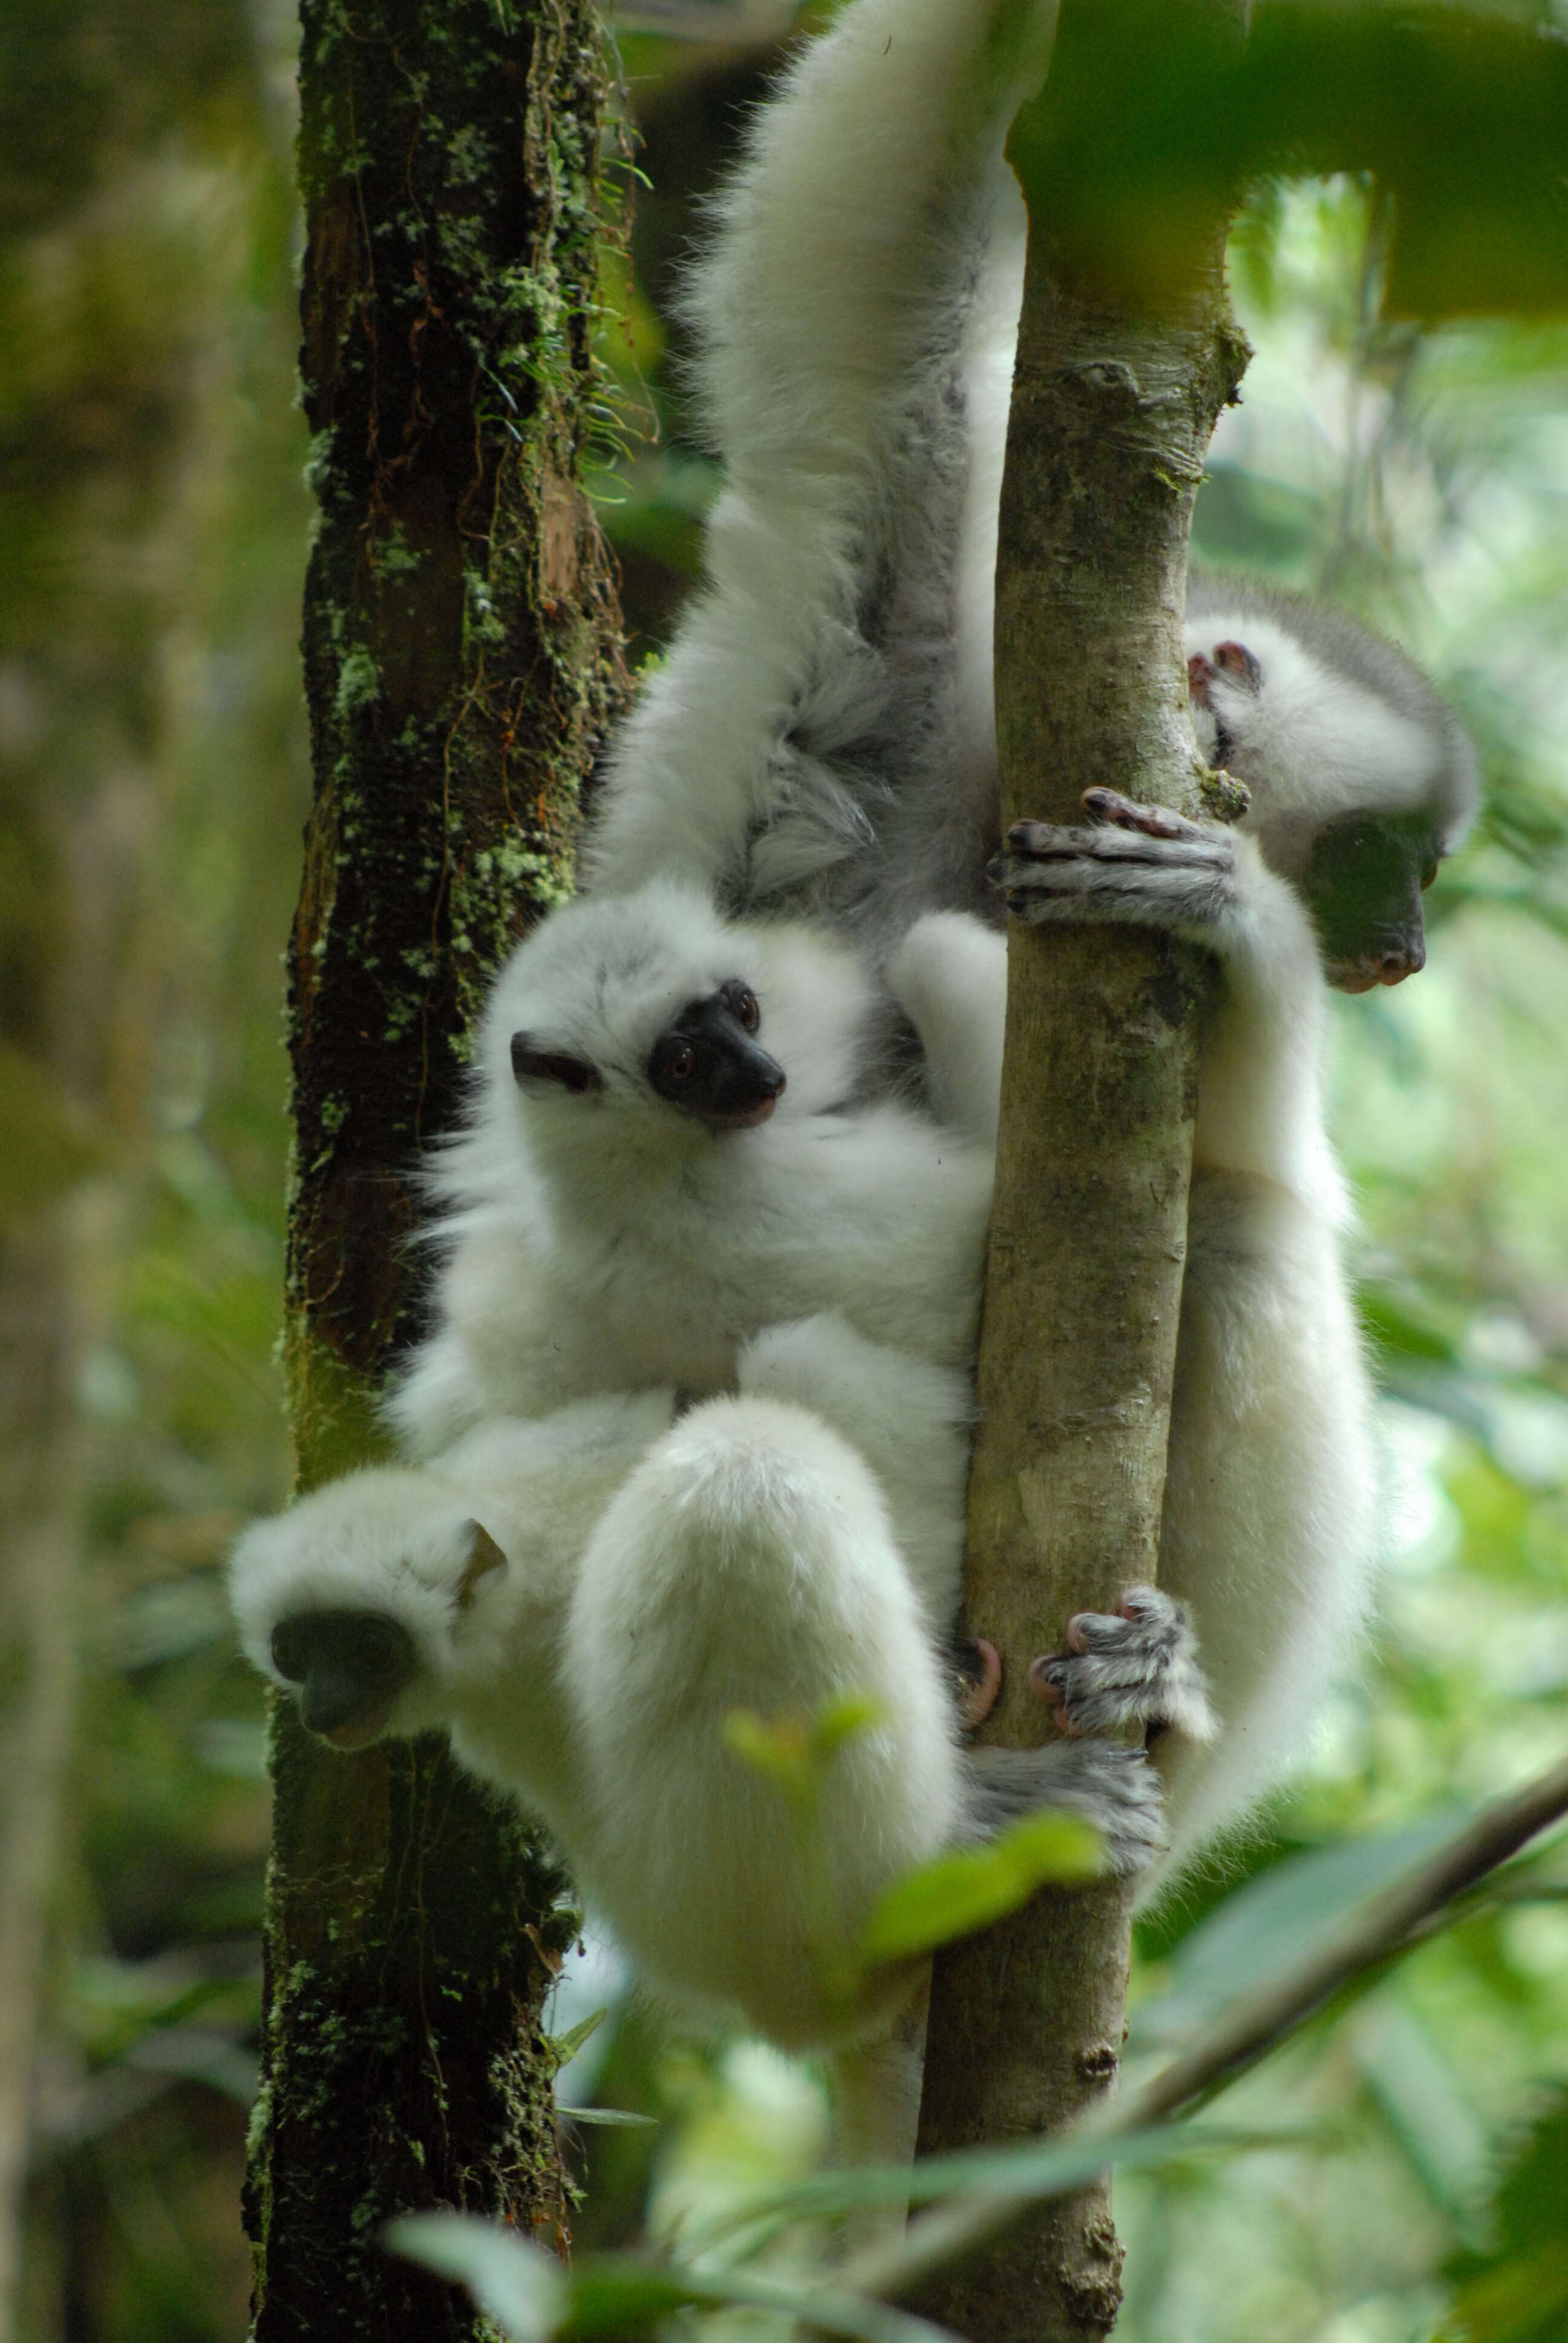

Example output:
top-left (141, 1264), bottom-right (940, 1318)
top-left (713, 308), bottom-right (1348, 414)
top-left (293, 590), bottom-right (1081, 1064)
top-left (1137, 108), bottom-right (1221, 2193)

top-left (0, 0), bottom-right (307, 2343)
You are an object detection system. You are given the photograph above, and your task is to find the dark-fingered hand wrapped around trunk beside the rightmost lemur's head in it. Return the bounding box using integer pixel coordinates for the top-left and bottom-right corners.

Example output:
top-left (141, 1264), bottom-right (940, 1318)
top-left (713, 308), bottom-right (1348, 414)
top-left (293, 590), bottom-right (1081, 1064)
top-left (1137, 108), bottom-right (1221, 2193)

top-left (989, 790), bottom-right (1235, 930)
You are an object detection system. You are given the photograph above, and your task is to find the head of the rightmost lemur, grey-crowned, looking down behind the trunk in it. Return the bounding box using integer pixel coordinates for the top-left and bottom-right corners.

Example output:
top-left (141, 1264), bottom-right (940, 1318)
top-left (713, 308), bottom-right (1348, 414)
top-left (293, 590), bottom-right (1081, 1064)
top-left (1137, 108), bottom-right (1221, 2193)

top-left (1186, 577), bottom-right (1477, 994)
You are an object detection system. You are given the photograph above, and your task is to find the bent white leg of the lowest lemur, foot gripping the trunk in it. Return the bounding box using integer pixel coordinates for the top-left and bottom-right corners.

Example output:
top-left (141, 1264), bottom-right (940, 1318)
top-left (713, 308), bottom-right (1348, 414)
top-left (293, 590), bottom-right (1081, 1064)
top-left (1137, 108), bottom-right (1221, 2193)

top-left (563, 1397), bottom-right (1163, 2048)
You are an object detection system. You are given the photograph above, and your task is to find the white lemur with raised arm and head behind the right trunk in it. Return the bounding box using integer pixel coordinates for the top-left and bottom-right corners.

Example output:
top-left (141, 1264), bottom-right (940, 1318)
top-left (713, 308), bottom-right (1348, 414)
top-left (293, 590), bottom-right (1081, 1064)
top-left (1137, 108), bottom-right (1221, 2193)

top-left (569, 0), bottom-right (1477, 1863)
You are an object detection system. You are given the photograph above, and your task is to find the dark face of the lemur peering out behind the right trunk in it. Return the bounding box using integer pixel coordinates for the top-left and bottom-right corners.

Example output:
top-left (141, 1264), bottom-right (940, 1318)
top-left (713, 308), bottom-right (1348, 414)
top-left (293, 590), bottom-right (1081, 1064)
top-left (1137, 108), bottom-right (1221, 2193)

top-left (1305, 813), bottom-right (1439, 994)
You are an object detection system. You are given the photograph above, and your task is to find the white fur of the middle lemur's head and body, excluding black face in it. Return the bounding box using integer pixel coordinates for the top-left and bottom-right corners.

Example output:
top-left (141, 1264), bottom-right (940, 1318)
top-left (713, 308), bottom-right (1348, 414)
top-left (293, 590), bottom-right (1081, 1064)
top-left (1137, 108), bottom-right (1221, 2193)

top-left (391, 881), bottom-right (991, 1624)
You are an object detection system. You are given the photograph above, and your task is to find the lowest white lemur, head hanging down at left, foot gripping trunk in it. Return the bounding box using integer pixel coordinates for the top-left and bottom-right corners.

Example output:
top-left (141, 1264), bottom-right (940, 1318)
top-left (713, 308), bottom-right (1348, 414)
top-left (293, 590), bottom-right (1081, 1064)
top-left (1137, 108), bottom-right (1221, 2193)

top-left (232, 1314), bottom-right (1160, 2108)
